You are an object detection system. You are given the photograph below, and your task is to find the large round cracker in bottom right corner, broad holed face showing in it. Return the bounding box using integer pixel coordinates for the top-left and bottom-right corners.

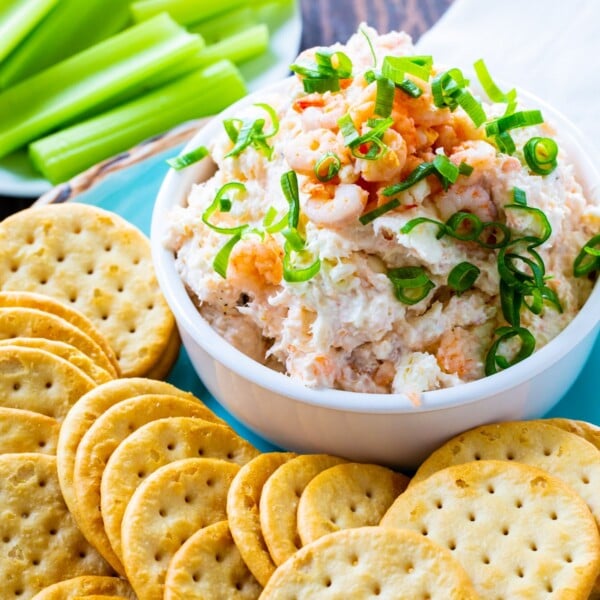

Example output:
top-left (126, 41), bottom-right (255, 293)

top-left (381, 460), bottom-right (600, 600)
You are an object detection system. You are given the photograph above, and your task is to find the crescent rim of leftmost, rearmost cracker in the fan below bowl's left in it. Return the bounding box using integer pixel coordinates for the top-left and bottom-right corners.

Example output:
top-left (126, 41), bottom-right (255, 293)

top-left (56, 377), bottom-right (206, 528)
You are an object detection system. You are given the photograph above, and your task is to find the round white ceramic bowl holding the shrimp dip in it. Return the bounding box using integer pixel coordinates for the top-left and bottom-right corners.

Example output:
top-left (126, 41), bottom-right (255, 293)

top-left (151, 77), bottom-right (600, 468)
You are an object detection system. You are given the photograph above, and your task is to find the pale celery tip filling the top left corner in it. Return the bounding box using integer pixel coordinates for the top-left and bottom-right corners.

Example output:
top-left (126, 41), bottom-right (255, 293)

top-left (0, 0), bottom-right (58, 61)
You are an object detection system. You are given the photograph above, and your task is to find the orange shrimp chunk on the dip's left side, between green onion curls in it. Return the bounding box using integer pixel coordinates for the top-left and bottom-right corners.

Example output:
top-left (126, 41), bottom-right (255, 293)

top-left (227, 235), bottom-right (283, 293)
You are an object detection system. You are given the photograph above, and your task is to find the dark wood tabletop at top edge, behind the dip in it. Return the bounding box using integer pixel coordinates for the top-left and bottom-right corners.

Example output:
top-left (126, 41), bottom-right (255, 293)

top-left (301, 0), bottom-right (452, 49)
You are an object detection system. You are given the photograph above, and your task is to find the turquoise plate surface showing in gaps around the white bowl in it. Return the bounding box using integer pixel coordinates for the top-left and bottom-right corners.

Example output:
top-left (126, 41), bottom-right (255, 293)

top-left (77, 148), bottom-right (600, 450)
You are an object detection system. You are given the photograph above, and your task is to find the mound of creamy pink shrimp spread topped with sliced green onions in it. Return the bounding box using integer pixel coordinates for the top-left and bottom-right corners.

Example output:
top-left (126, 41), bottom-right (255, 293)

top-left (166, 26), bottom-right (600, 395)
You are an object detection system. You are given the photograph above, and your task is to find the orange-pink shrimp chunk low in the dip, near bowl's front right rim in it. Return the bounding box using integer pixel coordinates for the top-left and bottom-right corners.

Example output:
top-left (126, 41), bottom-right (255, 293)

top-left (436, 327), bottom-right (484, 381)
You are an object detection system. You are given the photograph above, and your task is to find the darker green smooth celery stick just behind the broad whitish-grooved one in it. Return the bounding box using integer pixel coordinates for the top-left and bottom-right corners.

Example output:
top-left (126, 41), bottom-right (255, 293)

top-left (0, 0), bottom-right (130, 88)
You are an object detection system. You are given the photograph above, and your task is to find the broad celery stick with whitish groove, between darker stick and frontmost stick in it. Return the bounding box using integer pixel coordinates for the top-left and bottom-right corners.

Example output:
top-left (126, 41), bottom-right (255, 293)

top-left (0, 14), bottom-right (202, 157)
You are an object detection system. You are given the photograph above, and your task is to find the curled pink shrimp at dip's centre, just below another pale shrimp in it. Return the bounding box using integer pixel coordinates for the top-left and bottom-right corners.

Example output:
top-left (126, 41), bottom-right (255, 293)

top-left (302, 183), bottom-right (369, 228)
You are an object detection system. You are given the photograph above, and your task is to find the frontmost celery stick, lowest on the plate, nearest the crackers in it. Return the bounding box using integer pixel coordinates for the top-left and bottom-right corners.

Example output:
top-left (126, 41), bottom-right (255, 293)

top-left (29, 61), bottom-right (246, 183)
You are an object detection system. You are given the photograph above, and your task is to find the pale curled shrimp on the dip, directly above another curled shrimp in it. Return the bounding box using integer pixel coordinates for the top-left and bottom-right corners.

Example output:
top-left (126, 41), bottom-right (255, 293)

top-left (283, 129), bottom-right (348, 177)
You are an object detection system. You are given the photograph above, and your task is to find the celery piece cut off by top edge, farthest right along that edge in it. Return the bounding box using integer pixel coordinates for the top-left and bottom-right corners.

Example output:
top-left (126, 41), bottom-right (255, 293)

top-left (131, 0), bottom-right (246, 25)
